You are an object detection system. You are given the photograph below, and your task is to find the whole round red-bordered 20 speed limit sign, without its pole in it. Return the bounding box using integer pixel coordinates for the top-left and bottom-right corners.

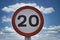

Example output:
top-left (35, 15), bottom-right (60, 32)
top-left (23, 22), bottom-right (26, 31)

top-left (12, 6), bottom-right (44, 37)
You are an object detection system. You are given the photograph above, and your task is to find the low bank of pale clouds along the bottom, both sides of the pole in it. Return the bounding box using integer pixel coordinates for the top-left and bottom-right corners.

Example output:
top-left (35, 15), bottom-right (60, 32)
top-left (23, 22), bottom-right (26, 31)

top-left (0, 26), bottom-right (60, 40)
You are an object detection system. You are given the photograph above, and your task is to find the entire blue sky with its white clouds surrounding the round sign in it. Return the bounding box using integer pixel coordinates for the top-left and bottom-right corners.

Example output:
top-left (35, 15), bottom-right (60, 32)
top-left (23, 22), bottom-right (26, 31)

top-left (0, 0), bottom-right (60, 40)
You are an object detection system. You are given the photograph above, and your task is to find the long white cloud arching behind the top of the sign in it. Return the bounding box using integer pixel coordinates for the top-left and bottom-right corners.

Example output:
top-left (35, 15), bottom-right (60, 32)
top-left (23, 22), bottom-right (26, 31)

top-left (2, 3), bottom-right (55, 14)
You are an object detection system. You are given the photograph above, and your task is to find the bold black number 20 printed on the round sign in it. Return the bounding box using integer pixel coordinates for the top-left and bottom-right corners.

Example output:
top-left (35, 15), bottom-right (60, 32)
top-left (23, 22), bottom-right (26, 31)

top-left (17, 15), bottom-right (39, 27)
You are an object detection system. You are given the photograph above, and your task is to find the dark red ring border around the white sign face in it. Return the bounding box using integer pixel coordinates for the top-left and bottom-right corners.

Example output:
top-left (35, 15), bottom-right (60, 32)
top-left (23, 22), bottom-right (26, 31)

top-left (12, 6), bottom-right (44, 37)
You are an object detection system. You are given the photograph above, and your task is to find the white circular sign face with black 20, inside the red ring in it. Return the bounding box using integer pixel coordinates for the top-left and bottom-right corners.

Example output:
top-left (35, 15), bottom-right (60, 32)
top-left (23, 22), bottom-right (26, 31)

top-left (15, 9), bottom-right (40, 33)
